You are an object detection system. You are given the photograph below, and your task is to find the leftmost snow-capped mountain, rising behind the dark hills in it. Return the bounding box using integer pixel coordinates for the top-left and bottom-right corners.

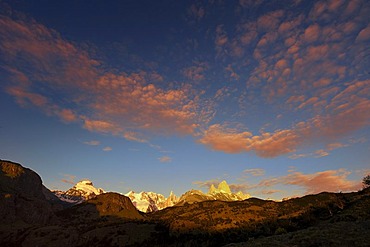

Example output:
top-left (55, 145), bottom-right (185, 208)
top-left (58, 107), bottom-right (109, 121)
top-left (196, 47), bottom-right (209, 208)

top-left (52, 180), bottom-right (105, 204)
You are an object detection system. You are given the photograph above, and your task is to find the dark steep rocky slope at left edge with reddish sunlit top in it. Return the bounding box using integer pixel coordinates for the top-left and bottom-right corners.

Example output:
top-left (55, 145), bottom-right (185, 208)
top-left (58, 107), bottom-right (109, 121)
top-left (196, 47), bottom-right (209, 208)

top-left (0, 160), bottom-right (61, 224)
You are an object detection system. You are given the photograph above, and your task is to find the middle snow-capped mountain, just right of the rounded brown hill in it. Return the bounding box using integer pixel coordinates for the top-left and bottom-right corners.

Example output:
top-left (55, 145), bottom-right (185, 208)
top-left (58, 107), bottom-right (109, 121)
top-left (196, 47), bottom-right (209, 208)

top-left (125, 191), bottom-right (178, 213)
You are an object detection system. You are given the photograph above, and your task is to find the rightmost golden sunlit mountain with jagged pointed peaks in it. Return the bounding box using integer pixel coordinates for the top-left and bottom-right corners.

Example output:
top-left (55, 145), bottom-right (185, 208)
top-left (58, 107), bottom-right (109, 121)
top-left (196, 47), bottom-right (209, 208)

top-left (176, 180), bottom-right (250, 206)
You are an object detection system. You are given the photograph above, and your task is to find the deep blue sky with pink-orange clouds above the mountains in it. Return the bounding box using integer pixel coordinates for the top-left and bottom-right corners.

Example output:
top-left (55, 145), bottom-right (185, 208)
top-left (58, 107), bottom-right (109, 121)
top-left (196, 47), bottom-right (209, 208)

top-left (0, 0), bottom-right (370, 199)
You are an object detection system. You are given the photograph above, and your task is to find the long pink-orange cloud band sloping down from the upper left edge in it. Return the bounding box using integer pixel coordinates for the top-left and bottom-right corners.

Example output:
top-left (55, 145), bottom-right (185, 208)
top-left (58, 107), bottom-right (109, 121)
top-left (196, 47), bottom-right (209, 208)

top-left (0, 16), bottom-right (210, 142)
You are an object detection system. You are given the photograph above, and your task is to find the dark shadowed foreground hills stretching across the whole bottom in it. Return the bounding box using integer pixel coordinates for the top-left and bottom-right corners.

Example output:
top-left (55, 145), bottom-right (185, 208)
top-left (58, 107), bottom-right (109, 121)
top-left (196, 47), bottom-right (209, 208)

top-left (0, 160), bottom-right (370, 247)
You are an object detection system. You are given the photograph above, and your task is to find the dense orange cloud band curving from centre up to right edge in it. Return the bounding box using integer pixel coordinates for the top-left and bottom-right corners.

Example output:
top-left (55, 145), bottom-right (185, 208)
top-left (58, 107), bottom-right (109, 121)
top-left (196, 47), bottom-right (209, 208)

top-left (198, 78), bottom-right (370, 158)
